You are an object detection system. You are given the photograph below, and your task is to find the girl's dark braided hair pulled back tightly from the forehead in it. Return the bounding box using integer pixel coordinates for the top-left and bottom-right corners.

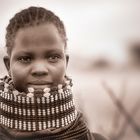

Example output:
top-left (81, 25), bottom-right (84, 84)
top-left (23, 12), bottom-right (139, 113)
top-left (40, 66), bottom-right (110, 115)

top-left (5, 6), bottom-right (67, 55)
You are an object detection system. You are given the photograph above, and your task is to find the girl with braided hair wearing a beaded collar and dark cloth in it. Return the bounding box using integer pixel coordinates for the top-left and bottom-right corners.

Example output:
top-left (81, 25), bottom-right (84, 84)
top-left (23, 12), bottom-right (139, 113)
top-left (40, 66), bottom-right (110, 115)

top-left (0, 7), bottom-right (107, 140)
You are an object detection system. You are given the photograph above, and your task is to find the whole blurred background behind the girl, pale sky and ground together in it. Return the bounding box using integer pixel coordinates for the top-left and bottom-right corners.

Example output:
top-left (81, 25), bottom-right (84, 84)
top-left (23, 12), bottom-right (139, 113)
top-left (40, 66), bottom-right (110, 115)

top-left (0, 0), bottom-right (140, 140)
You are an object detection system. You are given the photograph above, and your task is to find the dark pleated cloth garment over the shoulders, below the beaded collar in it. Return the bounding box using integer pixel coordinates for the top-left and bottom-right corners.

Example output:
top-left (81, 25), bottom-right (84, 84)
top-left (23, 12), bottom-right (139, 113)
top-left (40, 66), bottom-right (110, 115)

top-left (0, 113), bottom-right (106, 140)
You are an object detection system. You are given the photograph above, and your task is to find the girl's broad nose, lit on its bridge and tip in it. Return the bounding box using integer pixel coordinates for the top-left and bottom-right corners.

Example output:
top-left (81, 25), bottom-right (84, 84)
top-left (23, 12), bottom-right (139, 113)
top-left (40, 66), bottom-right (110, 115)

top-left (31, 62), bottom-right (48, 76)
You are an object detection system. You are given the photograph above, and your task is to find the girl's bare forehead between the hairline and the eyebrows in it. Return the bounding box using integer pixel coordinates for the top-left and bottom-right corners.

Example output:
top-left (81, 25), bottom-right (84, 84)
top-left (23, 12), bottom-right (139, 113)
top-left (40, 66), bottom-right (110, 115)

top-left (12, 24), bottom-right (65, 52)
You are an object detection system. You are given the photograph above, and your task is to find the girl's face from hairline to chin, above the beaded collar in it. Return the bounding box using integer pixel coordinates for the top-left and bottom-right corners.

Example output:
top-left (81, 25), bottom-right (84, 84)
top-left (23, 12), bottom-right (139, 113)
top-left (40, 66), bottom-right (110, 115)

top-left (4, 24), bottom-right (67, 92)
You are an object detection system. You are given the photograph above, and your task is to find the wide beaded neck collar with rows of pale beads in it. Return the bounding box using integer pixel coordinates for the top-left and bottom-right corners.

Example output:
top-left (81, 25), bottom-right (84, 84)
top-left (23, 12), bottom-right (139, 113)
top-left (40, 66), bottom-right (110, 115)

top-left (0, 76), bottom-right (77, 132)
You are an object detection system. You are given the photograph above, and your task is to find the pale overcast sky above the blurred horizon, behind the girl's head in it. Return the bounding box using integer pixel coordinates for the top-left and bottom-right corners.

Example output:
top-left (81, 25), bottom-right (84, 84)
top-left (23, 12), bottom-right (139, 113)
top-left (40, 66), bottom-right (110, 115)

top-left (0, 0), bottom-right (140, 61)
